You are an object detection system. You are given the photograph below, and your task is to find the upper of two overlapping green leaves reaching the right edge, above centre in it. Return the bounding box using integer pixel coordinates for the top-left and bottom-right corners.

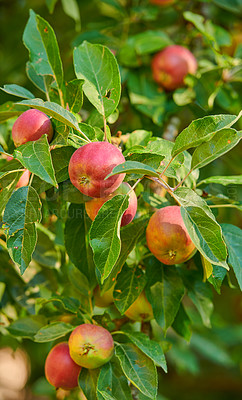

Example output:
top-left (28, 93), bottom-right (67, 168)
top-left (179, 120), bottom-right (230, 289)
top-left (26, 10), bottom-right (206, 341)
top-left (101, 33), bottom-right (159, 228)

top-left (171, 114), bottom-right (240, 157)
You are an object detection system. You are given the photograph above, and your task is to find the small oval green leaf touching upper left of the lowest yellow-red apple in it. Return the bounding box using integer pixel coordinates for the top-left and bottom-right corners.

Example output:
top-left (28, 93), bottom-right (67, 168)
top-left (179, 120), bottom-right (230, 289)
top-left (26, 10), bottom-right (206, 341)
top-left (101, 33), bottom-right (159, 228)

top-left (34, 322), bottom-right (74, 343)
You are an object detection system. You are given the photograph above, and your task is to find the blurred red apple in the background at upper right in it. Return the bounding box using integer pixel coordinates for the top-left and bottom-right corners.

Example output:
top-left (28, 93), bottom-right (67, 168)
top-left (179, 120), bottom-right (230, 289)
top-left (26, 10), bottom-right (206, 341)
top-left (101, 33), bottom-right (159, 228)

top-left (151, 45), bottom-right (197, 90)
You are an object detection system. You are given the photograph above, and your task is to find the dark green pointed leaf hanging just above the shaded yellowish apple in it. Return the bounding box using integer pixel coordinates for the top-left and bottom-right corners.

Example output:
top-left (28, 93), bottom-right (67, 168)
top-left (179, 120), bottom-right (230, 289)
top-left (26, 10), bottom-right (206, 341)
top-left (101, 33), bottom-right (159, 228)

top-left (114, 266), bottom-right (146, 315)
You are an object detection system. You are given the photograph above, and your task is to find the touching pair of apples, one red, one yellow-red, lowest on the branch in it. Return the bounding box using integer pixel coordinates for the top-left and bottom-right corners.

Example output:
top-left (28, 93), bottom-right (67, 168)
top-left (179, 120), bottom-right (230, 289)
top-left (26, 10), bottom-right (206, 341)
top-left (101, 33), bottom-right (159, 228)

top-left (45, 324), bottom-right (114, 390)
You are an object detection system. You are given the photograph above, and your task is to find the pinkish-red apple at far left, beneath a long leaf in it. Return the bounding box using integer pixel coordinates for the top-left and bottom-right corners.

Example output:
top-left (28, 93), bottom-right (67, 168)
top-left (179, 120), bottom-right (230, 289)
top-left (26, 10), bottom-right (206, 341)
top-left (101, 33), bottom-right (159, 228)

top-left (12, 109), bottom-right (53, 147)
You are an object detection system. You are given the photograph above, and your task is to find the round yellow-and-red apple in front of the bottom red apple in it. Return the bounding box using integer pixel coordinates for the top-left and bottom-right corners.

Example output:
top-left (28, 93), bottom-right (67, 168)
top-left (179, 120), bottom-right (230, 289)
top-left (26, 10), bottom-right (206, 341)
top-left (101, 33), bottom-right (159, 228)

top-left (68, 324), bottom-right (114, 369)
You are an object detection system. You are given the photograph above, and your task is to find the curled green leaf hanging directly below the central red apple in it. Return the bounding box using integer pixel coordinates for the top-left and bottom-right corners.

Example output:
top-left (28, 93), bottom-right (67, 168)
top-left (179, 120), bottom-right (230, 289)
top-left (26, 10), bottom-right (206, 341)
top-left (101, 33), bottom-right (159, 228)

top-left (90, 195), bottom-right (128, 283)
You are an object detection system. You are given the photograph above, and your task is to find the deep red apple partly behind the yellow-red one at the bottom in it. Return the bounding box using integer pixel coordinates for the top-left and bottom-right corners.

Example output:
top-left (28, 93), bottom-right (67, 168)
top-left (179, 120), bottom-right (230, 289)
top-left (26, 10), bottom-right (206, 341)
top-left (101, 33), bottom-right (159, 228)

top-left (45, 342), bottom-right (81, 390)
